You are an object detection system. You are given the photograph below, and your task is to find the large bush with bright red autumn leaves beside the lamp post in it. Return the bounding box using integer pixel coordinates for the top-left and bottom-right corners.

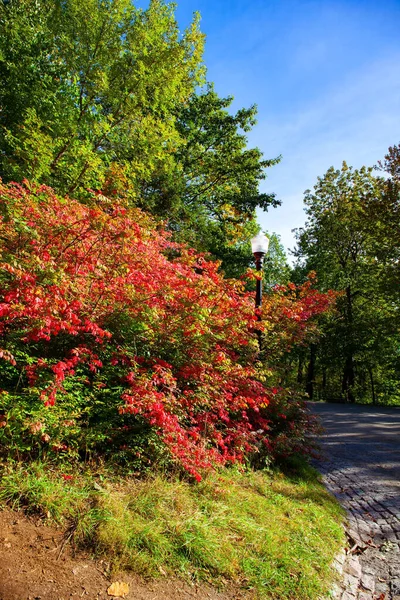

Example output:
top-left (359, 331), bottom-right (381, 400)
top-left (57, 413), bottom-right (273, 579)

top-left (0, 182), bottom-right (329, 479)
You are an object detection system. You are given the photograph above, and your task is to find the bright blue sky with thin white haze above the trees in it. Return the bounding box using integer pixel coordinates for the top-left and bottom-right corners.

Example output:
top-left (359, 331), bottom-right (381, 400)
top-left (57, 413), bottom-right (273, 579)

top-left (176, 0), bottom-right (400, 258)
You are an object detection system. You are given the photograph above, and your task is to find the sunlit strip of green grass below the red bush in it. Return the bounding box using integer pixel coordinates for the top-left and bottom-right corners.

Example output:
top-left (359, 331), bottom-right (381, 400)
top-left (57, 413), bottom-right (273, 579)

top-left (0, 463), bottom-right (343, 600)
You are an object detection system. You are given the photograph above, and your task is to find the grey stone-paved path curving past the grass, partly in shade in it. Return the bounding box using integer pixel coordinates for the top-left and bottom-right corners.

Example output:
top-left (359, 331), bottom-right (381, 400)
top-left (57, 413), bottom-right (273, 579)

top-left (310, 402), bottom-right (400, 600)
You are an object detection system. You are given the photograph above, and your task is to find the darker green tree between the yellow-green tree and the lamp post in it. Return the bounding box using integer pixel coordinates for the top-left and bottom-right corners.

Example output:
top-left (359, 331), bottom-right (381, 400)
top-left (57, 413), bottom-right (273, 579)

top-left (136, 85), bottom-right (280, 276)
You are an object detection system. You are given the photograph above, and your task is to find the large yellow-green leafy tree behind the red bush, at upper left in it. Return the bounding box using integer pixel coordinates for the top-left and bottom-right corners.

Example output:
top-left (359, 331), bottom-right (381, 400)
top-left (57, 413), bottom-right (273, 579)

top-left (0, 0), bottom-right (204, 199)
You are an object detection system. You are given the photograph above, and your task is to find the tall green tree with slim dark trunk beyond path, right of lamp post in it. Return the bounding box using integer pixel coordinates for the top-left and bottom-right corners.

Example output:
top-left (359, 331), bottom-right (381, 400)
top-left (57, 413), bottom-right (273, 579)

top-left (297, 163), bottom-right (398, 402)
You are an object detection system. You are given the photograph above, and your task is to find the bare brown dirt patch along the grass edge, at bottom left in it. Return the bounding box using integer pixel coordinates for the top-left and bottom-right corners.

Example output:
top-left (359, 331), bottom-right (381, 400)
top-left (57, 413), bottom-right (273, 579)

top-left (0, 509), bottom-right (252, 600)
